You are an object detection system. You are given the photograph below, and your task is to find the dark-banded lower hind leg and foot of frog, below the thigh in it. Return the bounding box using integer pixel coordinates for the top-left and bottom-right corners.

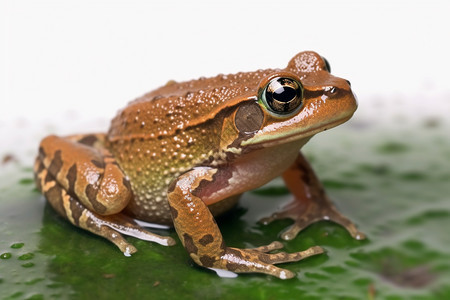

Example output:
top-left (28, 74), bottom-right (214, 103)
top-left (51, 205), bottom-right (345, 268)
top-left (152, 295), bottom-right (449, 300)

top-left (34, 158), bottom-right (175, 256)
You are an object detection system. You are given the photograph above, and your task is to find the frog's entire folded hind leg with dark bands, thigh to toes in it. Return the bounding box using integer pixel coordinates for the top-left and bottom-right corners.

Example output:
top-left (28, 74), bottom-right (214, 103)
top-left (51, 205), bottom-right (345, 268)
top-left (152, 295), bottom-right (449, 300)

top-left (34, 134), bottom-right (175, 255)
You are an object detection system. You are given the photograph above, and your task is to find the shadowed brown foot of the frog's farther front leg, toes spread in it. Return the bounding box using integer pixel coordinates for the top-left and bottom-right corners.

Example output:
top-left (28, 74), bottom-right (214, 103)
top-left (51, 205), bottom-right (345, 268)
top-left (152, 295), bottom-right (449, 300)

top-left (260, 196), bottom-right (366, 240)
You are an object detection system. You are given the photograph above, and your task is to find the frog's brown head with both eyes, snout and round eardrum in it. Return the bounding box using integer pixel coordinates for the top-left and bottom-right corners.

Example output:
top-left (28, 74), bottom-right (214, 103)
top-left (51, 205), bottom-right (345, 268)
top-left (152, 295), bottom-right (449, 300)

top-left (227, 52), bottom-right (357, 147)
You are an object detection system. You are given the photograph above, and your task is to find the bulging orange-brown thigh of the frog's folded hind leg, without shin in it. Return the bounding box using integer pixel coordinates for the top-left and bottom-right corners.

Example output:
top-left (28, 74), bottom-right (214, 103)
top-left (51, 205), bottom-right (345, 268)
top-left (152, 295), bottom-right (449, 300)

top-left (39, 135), bottom-right (132, 215)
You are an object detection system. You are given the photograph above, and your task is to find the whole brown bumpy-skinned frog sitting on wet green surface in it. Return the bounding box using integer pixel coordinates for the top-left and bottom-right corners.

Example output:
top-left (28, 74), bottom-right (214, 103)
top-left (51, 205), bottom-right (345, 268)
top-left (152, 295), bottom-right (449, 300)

top-left (34, 51), bottom-right (365, 279)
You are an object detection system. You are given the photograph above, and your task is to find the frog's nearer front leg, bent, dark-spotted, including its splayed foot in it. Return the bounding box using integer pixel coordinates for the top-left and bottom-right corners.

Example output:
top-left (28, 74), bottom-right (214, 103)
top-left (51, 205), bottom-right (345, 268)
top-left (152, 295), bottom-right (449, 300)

top-left (168, 167), bottom-right (323, 279)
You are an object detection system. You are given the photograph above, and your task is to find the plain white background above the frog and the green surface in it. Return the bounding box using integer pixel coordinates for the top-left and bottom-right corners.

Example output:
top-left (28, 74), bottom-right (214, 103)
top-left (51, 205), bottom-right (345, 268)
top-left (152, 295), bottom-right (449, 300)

top-left (0, 0), bottom-right (450, 127)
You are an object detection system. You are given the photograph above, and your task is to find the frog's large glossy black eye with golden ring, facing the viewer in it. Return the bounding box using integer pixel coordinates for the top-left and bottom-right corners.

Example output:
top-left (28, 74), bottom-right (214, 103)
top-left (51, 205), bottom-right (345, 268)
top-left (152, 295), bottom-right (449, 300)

top-left (261, 77), bottom-right (303, 115)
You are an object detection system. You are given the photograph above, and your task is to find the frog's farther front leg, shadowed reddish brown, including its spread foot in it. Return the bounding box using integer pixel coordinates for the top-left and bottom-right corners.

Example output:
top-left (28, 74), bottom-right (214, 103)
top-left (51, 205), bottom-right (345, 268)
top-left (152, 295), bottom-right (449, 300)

top-left (261, 153), bottom-right (366, 240)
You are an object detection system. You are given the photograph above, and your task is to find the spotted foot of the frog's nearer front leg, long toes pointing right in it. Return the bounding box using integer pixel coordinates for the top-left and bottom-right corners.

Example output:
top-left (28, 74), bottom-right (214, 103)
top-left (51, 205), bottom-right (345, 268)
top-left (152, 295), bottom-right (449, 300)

top-left (214, 242), bottom-right (324, 279)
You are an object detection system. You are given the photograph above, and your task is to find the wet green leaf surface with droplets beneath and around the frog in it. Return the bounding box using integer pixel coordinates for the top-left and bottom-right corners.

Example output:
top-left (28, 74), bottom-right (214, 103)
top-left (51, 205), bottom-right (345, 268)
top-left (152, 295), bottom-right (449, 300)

top-left (0, 115), bottom-right (450, 300)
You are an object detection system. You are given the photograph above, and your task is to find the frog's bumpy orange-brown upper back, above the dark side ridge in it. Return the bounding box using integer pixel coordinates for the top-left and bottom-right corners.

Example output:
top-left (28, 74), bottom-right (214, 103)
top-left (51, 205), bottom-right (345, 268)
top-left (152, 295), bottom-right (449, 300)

top-left (109, 69), bottom-right (276, 139)
